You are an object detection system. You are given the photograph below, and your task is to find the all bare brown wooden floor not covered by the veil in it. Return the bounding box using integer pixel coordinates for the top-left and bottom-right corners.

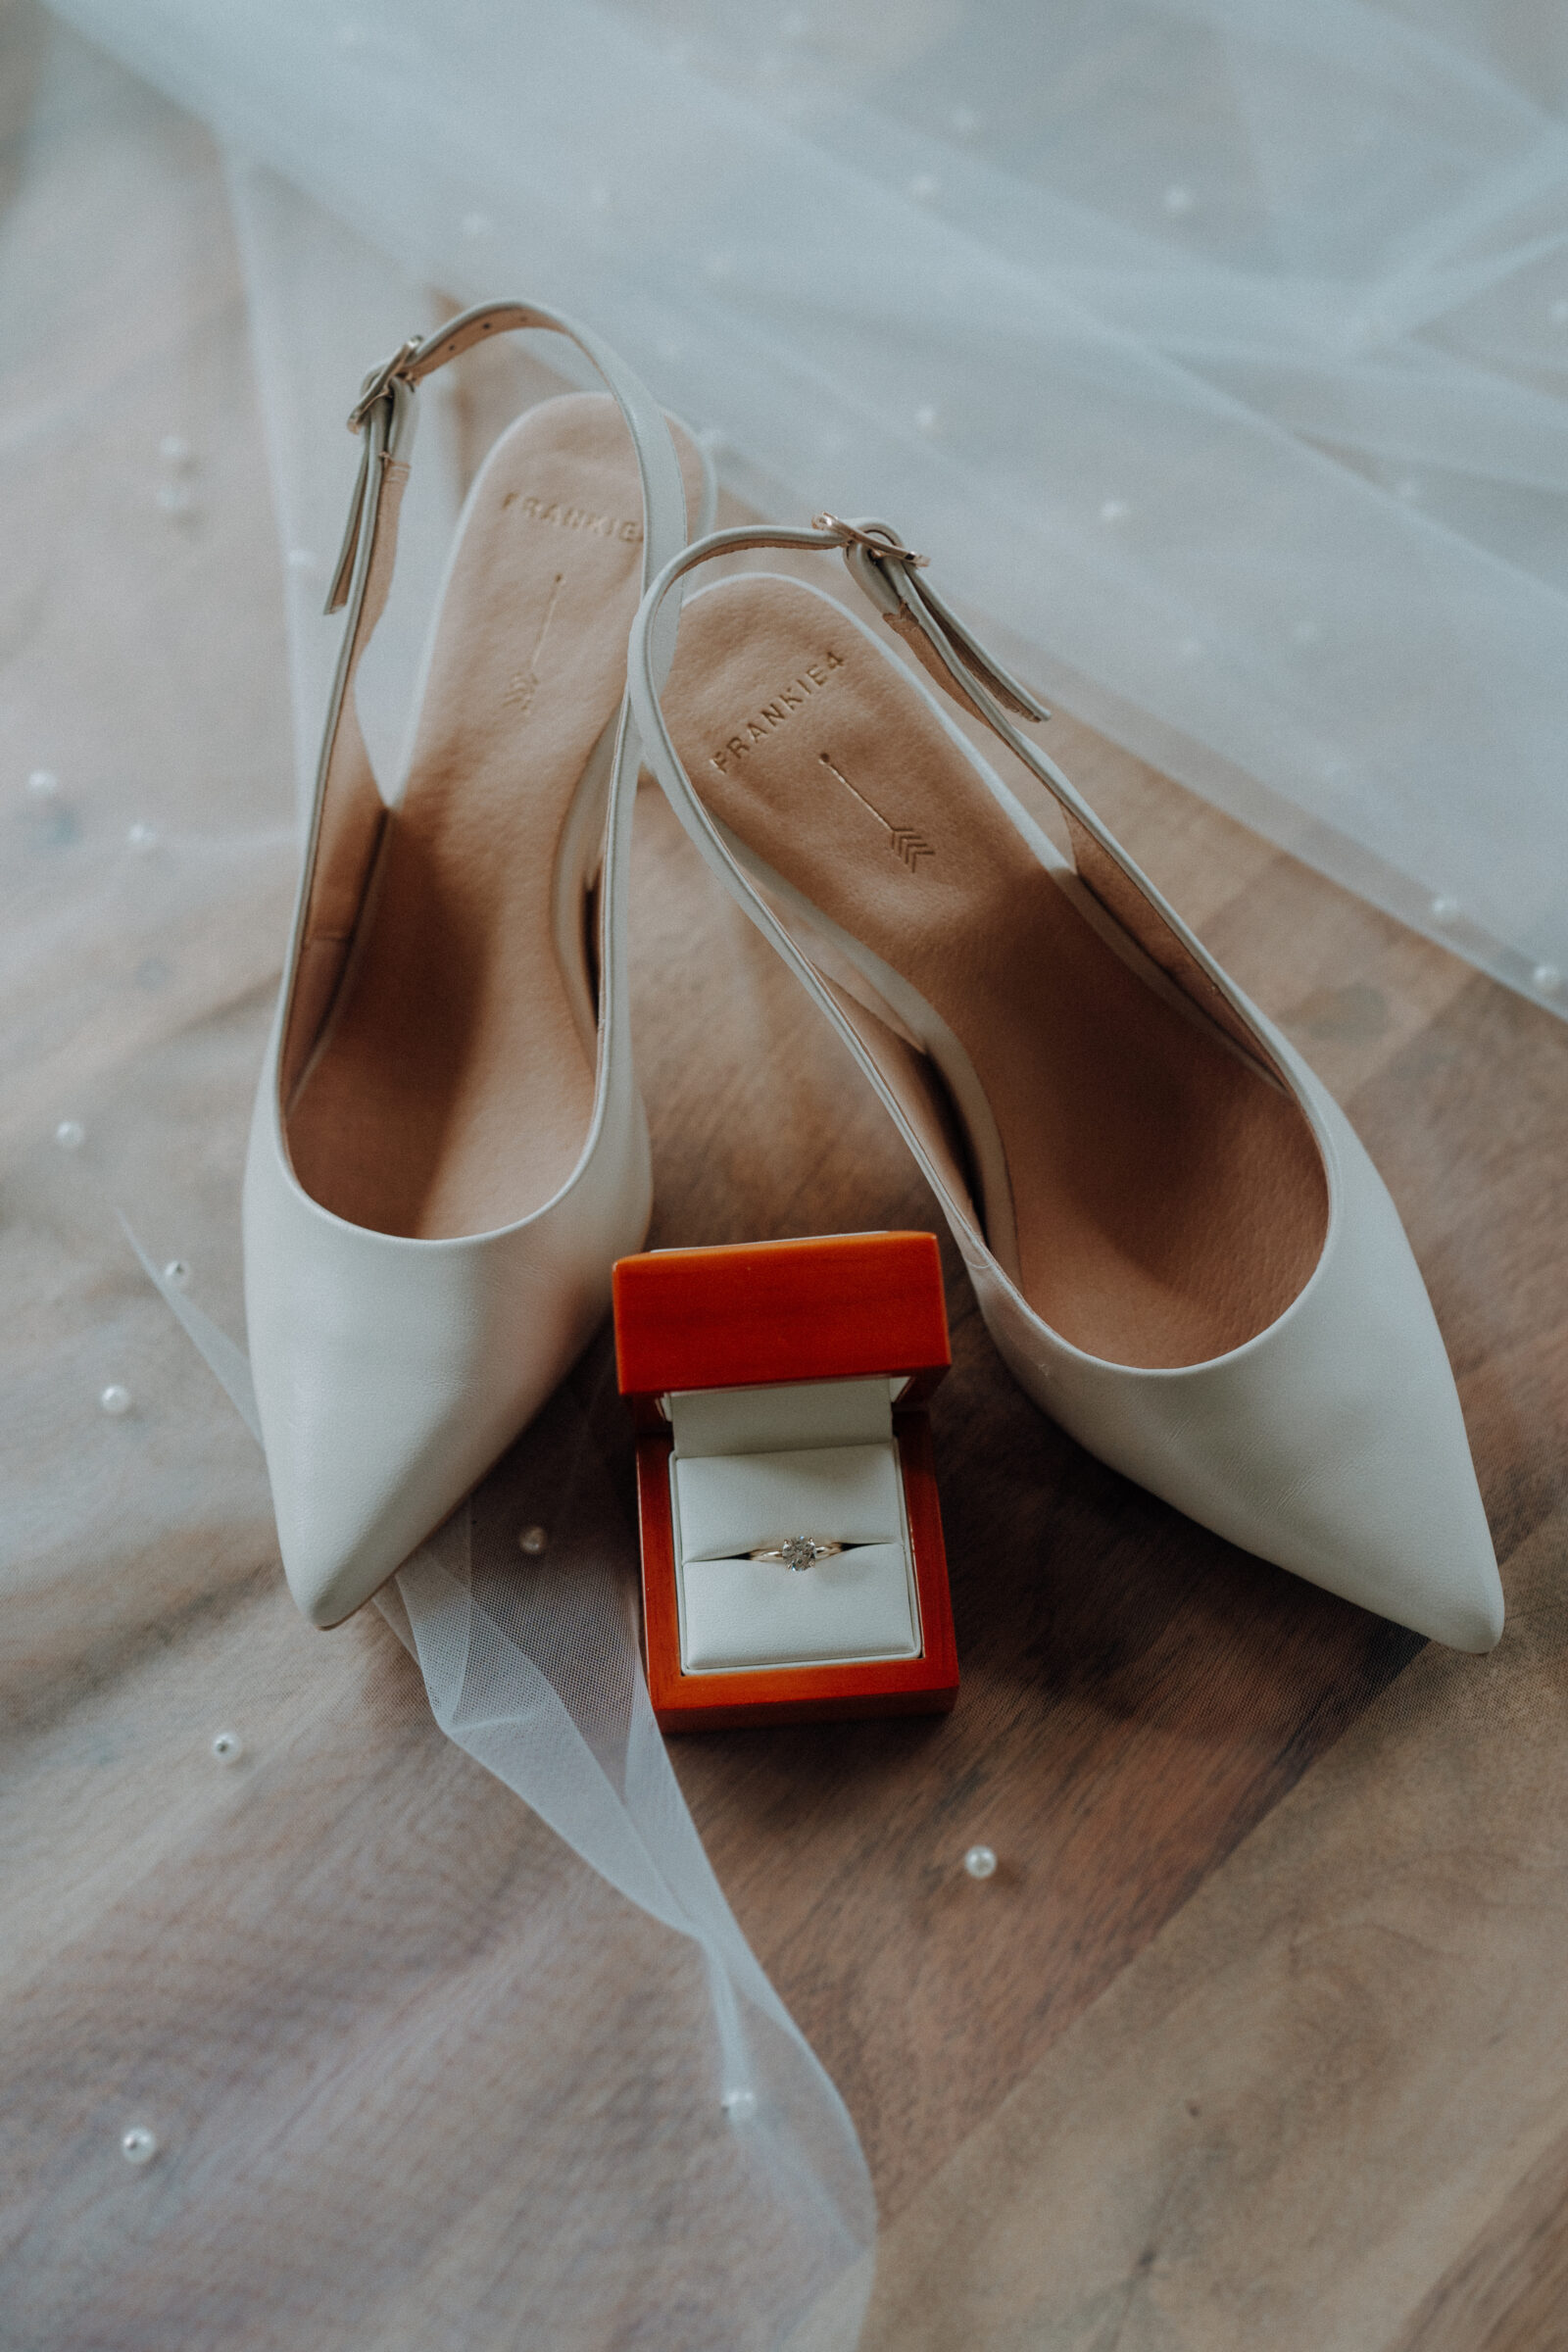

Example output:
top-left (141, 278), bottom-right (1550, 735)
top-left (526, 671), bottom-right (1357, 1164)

top-left (12, 14), bottom-right (1568, 2352)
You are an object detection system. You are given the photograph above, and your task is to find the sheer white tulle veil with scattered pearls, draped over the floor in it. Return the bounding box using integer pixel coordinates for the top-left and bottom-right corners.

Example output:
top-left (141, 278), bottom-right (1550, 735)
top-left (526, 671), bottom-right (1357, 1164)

top-left (12, 0), bottom-right (1568, 2352)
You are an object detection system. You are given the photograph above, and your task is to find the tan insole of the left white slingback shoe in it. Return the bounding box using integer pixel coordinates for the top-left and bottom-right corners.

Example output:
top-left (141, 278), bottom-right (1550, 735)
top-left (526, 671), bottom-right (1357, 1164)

top-left (287, 393), bottom-right (701, 1237)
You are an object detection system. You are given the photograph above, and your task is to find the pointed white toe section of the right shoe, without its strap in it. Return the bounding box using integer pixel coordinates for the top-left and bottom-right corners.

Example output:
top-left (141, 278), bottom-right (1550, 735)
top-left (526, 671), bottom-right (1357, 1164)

top-left (955, 1030), bottom-right (1502, 1651)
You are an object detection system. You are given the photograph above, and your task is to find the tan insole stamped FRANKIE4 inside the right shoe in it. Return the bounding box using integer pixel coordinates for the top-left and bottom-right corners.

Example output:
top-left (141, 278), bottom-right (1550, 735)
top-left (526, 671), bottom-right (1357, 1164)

top-left (665, 576), bottom-right (1326, 1366)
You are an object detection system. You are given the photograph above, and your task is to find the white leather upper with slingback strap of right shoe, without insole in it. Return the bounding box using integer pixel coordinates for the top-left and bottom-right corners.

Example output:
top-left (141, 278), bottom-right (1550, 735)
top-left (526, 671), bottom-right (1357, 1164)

top-left (630, 527), bottom-right (1502, 1651)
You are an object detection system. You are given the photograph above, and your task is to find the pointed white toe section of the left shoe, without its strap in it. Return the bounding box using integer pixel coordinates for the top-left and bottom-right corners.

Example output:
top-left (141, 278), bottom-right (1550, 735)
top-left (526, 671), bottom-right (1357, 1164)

top-left (244, 1042), bottom-right (651, 1625)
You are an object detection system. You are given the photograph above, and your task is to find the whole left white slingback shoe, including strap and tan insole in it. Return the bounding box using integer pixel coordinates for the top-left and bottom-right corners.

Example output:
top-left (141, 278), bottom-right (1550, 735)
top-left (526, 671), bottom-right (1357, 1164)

top-left (244, 304), bottom-right (712, 1625)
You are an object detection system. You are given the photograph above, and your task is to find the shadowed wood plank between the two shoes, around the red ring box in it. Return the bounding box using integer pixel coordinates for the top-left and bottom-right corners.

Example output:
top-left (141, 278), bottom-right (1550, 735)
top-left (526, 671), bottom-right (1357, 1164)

top-left (635, 795), bottom-right (1420, 2211)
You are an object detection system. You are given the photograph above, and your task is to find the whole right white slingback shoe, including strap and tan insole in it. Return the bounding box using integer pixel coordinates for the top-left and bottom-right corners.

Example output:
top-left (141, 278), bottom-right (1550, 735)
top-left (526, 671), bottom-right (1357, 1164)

top-left (630, 515), bottom-right (1502, 1651)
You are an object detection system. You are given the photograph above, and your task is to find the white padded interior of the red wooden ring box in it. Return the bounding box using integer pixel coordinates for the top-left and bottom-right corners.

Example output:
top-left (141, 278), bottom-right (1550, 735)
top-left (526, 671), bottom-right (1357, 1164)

top-left (665, 1381), bottom-right (919, 1675)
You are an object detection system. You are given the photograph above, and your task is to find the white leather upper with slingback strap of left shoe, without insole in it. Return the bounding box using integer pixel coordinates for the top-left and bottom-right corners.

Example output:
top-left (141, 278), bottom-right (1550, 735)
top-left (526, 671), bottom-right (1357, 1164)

top-left (244, 304), bottom-right (710, 1625)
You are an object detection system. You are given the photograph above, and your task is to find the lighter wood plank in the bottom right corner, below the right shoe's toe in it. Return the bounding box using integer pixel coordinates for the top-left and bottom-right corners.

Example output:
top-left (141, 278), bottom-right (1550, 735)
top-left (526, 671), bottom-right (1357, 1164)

top-left (846, 1510), bottom-right (1568, 2352)
